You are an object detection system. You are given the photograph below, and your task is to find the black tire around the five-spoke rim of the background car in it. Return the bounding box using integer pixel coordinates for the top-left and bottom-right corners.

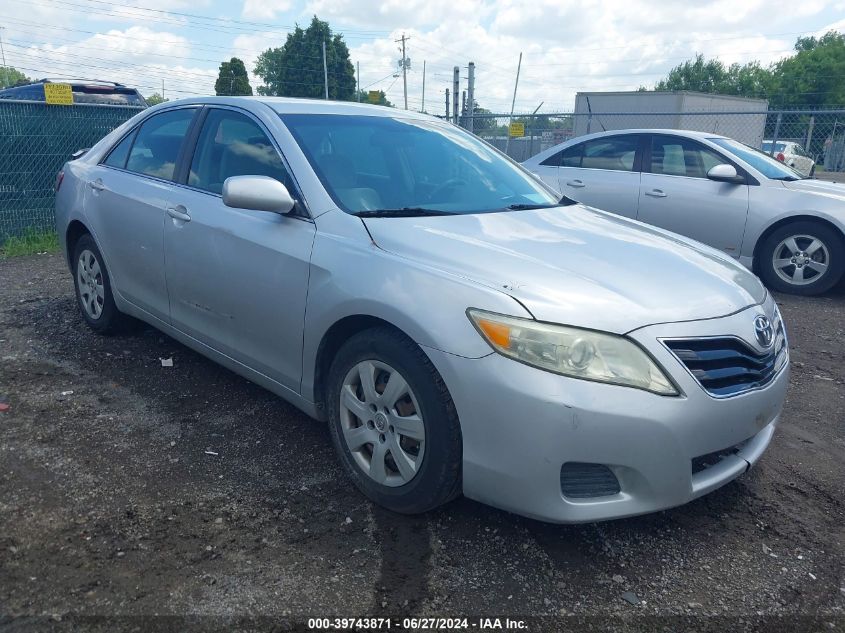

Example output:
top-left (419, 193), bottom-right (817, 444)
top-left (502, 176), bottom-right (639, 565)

top-left (758, 220), bottom-right (845, 295)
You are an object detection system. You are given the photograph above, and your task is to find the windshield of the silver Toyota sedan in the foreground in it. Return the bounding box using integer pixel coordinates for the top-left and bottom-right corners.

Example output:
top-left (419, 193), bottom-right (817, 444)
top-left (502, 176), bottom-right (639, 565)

top-left (280, 114), bottom-right (558, 217)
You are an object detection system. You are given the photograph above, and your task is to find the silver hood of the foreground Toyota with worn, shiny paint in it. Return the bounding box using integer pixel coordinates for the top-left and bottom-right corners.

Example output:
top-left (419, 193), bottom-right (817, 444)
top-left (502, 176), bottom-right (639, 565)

top-left (365, 205), bottom-right (766, 334)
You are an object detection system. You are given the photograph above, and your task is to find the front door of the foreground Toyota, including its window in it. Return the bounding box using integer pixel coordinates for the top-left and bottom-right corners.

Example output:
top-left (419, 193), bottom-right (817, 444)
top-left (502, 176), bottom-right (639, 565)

top-left (164, 108), bottom-right (315, 391)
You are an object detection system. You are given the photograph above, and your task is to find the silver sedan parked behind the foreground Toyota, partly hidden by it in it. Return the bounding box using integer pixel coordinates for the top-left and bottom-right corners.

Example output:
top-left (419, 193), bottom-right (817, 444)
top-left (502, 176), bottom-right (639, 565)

top-left (523, 130), bottom-right (845, 295)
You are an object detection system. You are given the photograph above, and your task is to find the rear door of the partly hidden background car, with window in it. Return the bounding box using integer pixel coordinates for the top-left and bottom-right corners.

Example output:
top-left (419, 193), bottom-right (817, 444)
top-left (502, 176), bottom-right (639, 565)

top-left (558, 134), bottom-right (642, 218)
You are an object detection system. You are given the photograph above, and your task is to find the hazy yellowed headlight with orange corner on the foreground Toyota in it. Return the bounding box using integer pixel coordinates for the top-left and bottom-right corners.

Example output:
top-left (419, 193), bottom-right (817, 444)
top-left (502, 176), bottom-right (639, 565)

top-left (467, 308), bottom-right (678, 396)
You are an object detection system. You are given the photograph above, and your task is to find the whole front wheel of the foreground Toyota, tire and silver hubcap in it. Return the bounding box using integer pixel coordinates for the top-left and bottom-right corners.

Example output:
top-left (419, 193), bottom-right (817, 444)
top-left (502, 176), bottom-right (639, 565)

top-left (327, 328), bottom-right (462, 514)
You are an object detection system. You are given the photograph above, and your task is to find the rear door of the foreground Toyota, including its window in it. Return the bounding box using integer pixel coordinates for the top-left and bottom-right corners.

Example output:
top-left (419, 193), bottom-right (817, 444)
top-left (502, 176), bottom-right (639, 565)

top-left (86, 107), bottom-right (198, 322)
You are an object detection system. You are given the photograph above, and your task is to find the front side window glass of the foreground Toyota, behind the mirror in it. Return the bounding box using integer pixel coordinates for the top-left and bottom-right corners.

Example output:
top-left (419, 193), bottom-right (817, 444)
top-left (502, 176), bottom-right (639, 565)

top-left (188, 109), bottom-right (290, 193)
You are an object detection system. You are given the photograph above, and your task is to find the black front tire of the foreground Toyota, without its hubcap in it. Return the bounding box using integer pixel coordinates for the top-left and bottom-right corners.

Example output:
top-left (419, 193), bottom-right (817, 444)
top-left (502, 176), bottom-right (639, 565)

top-left (326, 327), bottom-right (462, 514)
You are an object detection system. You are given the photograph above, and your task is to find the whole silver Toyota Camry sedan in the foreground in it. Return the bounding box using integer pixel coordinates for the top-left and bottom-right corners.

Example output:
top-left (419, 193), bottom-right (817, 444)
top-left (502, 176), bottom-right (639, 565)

top-left (56, 98), bottom-right (789, 522)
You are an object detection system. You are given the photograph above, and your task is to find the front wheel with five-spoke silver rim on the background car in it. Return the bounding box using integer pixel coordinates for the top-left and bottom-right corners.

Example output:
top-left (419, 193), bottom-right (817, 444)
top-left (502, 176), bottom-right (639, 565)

top-left (759, 221), bottom-right (845, 295)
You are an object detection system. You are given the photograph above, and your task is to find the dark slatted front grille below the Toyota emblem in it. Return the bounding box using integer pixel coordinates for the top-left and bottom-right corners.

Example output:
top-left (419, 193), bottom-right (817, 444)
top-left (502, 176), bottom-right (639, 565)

top-left (665, 320), bottom-right (786, 397)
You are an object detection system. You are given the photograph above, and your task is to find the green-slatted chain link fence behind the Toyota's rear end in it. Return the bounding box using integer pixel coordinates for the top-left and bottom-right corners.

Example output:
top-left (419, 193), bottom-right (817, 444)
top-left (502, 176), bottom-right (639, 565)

top-left (0, 100), bottom-right (140, 244)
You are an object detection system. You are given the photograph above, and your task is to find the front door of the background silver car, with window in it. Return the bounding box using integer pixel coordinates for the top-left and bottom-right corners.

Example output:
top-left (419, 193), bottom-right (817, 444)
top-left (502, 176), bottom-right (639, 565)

top-left (637, 134), bottom-right (748, 257)
